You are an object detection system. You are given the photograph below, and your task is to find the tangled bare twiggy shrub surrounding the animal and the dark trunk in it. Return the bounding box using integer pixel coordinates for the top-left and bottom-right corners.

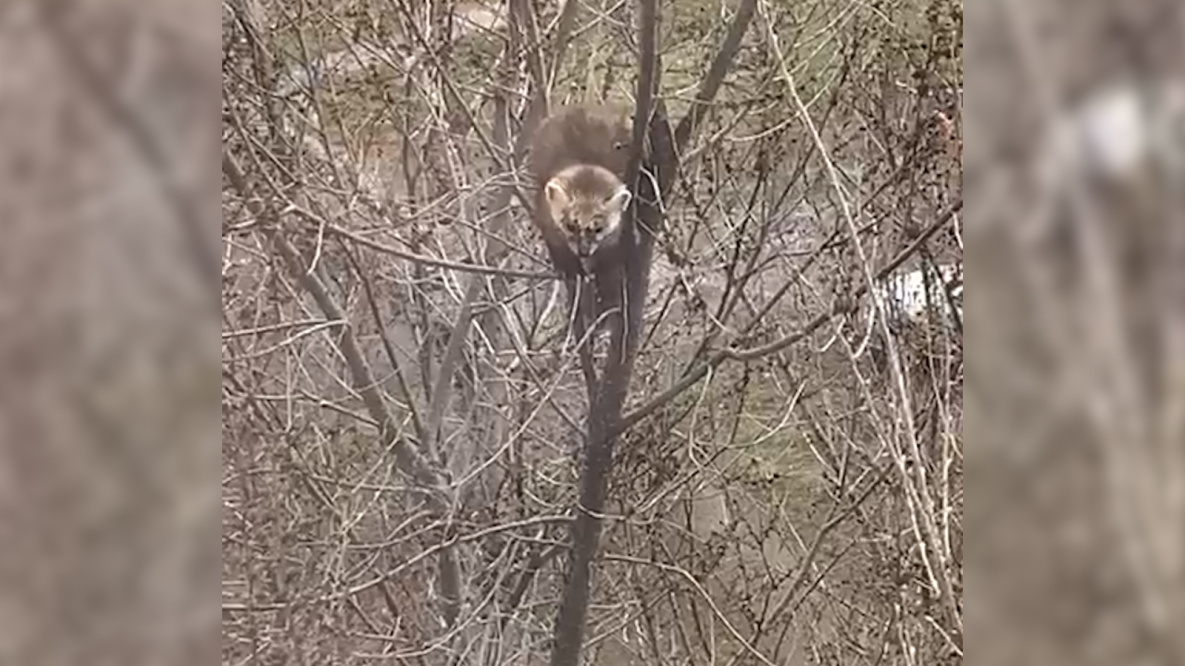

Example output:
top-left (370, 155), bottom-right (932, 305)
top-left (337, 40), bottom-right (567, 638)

top-left (222, 0), bottom-right (962, 664)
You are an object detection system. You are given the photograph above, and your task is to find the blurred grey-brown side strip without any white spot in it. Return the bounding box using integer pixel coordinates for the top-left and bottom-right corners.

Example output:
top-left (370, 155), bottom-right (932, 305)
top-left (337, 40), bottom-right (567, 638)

top-left (0, 1), bottom-right (220, 665)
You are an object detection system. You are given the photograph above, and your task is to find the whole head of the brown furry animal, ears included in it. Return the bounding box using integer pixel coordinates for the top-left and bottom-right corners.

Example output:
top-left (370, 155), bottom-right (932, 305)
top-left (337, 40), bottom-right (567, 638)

top-left (545, 166), bottom-right (630, 258)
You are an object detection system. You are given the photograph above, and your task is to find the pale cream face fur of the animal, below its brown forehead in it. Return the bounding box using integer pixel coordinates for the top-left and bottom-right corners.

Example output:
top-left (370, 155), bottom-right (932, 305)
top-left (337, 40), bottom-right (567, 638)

top-left (546, 178), bottom-right (630, 257)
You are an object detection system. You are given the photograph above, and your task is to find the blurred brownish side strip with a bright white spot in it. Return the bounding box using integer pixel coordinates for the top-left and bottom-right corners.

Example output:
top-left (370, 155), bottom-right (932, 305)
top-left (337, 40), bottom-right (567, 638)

top-left (963, 0), bottom-right (1185, 664)
